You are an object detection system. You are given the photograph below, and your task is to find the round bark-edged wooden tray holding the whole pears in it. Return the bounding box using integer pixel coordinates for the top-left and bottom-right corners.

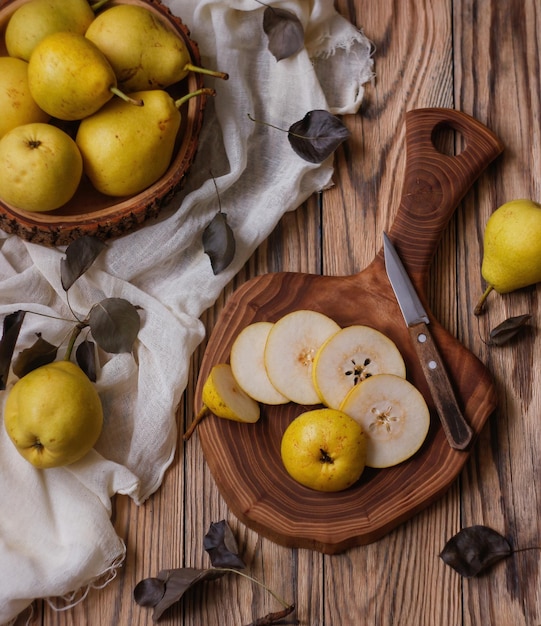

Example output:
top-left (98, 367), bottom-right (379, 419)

top-left (0, 0), bottom-right (206, 246)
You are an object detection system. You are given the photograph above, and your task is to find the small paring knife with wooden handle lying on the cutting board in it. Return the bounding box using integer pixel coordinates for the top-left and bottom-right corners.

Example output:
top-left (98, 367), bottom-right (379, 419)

top-left (383, 233), bottom-right (473, 450)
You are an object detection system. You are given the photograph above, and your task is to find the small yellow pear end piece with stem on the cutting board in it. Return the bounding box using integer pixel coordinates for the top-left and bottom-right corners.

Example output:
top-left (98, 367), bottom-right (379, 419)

top-left (184, 363), bottom-right (260, 441)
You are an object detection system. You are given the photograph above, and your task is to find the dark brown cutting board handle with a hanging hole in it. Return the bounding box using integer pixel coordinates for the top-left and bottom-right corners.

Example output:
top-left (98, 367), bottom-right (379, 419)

top-left (389, 108), bottom-right (503, 283)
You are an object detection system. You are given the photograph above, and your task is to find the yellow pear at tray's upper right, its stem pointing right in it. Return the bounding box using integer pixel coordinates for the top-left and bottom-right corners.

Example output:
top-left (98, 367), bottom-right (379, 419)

top-left (86, 4), bottom-right (227, 91)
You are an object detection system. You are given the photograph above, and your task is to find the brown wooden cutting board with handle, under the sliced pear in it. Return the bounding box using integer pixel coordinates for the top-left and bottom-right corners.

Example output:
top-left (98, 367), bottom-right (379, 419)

top-left (192, 109), bottom-right (503, 554)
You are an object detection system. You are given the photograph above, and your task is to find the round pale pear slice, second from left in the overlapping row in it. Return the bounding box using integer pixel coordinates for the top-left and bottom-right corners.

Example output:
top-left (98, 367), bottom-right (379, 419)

top-left (264, 309), bottom-right (340, 405)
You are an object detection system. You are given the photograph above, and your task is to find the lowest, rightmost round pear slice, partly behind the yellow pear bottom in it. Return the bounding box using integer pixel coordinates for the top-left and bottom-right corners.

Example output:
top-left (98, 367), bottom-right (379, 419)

top-left (340, 374), bottom-right (430, 468)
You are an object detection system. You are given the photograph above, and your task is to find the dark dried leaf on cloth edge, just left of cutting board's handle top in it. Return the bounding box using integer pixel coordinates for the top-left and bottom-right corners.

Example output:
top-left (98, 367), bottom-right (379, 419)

top-left (288, 109), bottom-right (350, 163)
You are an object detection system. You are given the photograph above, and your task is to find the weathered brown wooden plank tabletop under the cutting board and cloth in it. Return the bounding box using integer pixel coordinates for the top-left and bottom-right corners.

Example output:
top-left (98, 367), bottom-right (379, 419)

top-left (24, 0), bottom-right (541, 626)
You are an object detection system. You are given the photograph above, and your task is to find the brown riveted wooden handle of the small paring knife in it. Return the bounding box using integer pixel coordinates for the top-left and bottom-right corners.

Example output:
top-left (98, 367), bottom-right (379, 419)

top-left (409, 322), bottom-right (473, 450)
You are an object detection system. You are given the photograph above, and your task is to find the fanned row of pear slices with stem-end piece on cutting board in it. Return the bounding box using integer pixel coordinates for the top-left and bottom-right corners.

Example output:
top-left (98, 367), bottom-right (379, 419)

top-left (192, 309), bottom-right (430, 468)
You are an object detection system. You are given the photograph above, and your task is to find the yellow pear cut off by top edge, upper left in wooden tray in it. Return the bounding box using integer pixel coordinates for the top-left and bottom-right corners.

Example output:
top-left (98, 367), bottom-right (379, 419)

top-left (5, 0), bottom-right (98, 61)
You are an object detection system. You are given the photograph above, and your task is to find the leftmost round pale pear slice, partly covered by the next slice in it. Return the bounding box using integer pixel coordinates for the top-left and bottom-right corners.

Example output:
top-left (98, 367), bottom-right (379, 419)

top-left (230, 322), bottom-right (289, 405)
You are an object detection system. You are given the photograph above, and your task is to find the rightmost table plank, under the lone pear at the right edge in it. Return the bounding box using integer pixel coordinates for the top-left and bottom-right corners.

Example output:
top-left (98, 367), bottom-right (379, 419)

top-left (455, 0), bottom-right (541, 626)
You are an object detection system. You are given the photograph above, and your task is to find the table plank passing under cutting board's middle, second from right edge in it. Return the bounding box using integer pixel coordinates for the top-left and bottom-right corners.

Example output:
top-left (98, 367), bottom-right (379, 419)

top-left (320, 1), bottom-right (461, 626)
